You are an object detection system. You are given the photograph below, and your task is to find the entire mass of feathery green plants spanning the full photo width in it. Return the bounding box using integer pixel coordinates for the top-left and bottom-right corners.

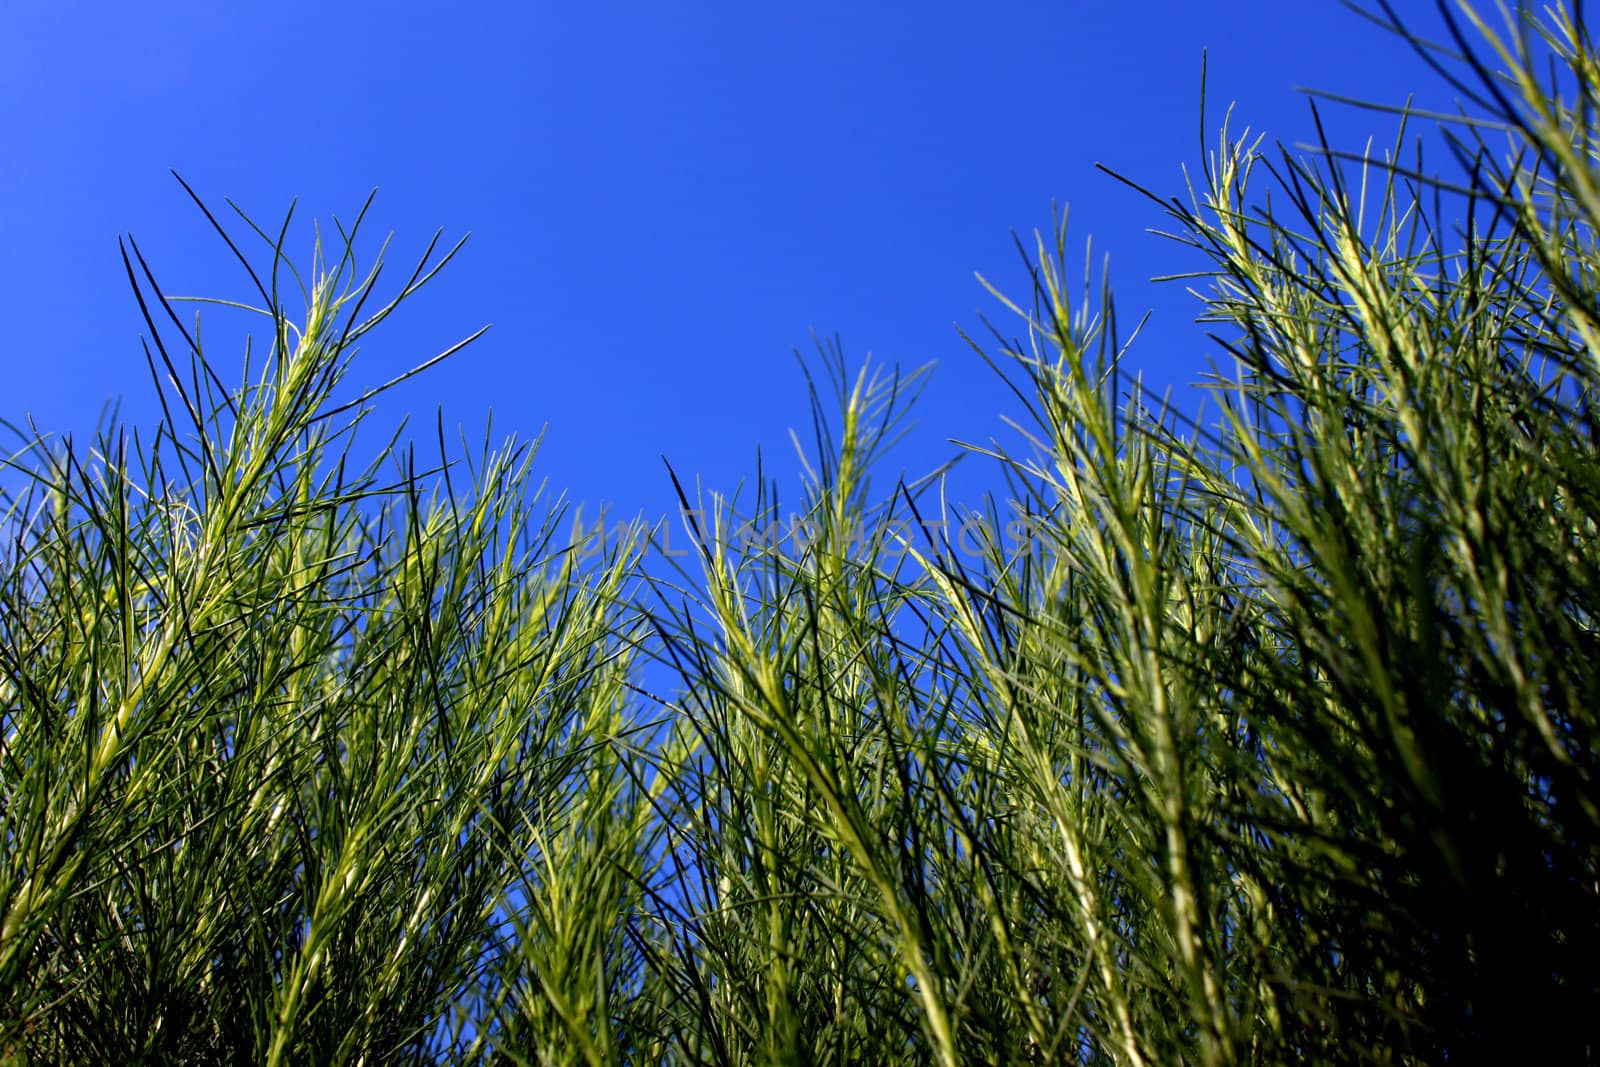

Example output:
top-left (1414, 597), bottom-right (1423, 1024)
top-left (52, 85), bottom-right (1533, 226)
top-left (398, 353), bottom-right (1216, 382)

top-left (0, 5), bottom-right (1600, 1064)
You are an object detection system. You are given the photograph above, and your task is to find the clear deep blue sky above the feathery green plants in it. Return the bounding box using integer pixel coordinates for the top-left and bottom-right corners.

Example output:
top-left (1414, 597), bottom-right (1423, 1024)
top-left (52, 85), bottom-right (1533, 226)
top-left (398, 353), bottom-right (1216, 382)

top-left (0, 0), bottom-right (1450, 534)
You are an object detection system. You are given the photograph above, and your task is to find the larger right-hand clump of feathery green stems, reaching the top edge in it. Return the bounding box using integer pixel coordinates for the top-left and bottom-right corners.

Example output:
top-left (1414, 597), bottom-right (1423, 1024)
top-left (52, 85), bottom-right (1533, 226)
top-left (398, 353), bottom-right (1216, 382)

top-left (630, 6), bottom-right (1600, 1064)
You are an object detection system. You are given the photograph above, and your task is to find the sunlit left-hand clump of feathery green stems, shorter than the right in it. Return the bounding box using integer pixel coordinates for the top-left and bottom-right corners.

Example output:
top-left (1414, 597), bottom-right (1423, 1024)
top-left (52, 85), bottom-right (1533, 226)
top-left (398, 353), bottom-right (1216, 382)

top-left (0, 191), bottom-right (649, 1062)
